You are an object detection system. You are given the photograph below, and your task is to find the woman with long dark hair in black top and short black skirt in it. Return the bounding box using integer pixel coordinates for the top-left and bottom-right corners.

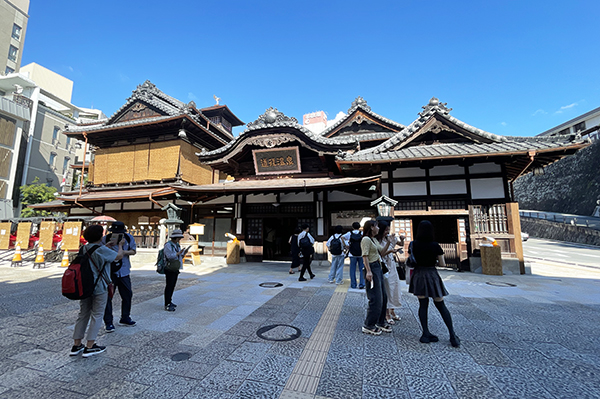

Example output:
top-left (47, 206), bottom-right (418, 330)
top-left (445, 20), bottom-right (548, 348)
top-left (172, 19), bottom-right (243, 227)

top-left (408, 220), bottom-right (460, 347)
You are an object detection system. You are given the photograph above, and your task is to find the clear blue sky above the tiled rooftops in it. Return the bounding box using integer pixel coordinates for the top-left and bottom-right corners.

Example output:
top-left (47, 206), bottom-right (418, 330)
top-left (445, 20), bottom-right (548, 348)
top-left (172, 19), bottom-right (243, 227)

top-left (22, 0), bottom-right (600, 136)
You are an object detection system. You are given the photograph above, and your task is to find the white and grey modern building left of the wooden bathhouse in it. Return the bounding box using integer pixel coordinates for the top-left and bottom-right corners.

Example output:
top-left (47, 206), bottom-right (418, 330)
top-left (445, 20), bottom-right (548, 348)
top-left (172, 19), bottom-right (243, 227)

top-left (0, 64), bottom-right (106, 215)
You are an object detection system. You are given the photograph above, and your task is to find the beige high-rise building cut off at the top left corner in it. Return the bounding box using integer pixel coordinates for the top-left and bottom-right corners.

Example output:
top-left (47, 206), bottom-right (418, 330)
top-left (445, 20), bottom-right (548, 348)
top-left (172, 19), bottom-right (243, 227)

top-left (0, 0), bottom-right (29, 75)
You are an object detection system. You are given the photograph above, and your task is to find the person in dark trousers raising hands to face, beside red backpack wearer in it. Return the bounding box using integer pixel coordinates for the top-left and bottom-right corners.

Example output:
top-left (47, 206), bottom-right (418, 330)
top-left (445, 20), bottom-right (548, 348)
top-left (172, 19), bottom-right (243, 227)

top-left (102, 221), bottom-right (137, 333)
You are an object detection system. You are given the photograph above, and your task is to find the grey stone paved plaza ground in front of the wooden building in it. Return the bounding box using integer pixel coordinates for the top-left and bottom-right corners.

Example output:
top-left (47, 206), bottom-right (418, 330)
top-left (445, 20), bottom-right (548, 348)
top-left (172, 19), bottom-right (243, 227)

top-left (0, 259), bottom-right (600, 399)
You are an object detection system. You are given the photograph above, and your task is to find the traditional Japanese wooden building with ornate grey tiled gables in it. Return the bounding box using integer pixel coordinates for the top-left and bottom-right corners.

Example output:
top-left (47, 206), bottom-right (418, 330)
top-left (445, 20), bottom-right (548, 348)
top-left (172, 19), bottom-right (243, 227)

top-left (38, 82), bottom-right (588, 272)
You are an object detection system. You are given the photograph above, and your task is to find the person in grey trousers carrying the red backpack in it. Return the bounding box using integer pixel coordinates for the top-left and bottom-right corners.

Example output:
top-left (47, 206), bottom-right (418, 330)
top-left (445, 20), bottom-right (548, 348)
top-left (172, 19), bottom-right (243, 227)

top-left (69, 224), bottom-right (125, 357)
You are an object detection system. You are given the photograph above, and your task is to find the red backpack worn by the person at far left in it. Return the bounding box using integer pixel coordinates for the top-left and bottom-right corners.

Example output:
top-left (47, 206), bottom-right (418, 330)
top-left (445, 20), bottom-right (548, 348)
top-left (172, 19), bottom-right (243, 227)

top-left (62, 245), bottom-right (104, 300)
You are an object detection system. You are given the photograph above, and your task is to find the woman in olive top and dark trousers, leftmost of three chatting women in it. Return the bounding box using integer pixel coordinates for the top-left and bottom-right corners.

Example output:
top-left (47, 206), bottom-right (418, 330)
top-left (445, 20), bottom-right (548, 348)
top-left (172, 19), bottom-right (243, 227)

top-left (360, 220), bottom-right (392, 335)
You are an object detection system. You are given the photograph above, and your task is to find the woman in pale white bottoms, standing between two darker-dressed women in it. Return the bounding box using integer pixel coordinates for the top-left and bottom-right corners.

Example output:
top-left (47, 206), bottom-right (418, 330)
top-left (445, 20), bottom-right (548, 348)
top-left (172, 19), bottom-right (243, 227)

top-left (376, 221), bottom-right (404, 324)
